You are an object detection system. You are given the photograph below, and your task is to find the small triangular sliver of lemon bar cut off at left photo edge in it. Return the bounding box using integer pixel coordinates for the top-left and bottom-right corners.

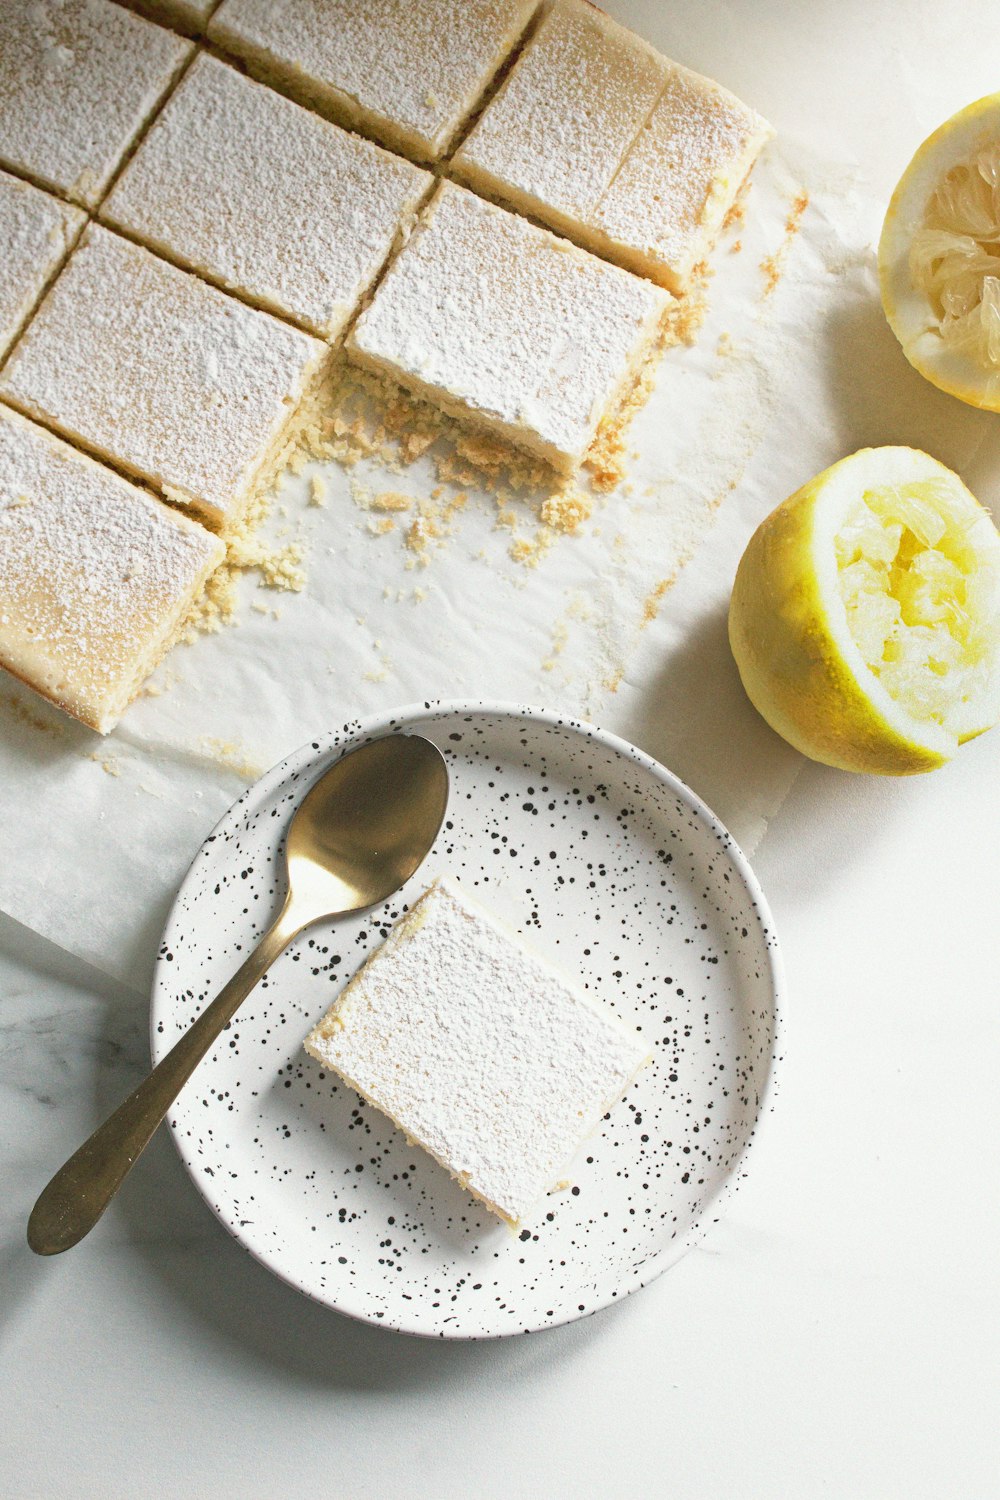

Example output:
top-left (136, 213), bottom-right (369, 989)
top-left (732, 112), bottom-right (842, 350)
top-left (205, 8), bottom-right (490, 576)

top-left (0, 173), bottom-right (87, 360)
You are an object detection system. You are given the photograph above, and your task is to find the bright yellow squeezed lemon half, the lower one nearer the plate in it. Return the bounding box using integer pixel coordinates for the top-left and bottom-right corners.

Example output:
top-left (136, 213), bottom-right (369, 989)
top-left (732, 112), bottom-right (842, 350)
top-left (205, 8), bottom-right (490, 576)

top-left (729, 447), bottom-right (1000, 776)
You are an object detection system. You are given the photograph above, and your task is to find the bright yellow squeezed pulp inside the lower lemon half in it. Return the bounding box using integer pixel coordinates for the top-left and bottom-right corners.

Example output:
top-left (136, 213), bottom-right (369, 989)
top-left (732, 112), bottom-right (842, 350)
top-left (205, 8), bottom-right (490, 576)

top-left (835, 480), bottom-right (1000, 738)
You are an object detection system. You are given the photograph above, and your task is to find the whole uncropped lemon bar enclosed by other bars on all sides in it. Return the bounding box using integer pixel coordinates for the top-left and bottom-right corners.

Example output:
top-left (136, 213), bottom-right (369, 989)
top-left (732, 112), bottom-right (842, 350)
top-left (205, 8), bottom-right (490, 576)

top-left (100, 54), bottom-right (432, 338)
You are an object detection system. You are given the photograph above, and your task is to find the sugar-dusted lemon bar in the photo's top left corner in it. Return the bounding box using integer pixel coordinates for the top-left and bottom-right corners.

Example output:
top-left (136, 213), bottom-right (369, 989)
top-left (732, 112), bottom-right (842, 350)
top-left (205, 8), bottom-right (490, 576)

top-left (0, 0), bottom-right (192, 209)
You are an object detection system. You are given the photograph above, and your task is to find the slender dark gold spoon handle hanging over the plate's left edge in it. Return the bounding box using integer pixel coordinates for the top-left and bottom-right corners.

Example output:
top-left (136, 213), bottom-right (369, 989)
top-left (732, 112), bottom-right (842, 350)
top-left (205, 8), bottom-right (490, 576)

top-left (28, 900), bottom-right (301, 1256)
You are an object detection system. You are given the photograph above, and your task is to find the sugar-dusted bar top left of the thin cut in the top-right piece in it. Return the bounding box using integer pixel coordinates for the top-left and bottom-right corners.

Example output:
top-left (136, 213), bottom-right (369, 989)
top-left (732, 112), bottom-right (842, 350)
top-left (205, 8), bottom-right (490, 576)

top-left (456, 0), bottom-right (670, 218)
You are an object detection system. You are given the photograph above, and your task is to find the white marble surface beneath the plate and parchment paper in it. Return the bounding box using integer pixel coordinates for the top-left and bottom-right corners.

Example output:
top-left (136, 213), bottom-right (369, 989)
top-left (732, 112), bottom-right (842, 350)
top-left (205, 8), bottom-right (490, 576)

top-left (0, 0), bottom-right (1000, 1500)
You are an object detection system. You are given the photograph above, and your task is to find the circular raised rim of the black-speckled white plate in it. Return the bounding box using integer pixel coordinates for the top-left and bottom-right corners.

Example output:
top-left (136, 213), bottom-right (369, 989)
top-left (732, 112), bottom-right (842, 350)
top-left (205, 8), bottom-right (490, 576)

top-left (150, 698), bottom-right (786, 1343)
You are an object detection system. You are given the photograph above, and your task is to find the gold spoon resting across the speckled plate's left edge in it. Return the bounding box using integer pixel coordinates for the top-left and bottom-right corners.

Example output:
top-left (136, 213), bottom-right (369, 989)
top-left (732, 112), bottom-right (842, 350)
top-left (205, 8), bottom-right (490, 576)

top-left (28, 735), bottom-right (448, 1256)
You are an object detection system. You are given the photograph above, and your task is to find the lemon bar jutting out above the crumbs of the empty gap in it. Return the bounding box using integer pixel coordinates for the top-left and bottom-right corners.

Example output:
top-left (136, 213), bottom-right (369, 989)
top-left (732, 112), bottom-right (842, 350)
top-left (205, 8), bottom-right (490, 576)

top-left (346, 183), bottom-right (669, 473)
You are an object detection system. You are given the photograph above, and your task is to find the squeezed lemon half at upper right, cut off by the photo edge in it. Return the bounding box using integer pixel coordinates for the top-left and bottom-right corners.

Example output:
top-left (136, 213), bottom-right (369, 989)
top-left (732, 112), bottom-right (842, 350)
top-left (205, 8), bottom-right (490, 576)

top-left (879, 95), bottom-right (1000, 411)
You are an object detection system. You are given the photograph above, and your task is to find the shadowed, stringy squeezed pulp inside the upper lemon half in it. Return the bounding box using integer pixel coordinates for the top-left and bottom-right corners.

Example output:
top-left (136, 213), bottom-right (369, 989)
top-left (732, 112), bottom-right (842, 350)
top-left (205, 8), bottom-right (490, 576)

top-left (910, 141), bottom-right (1000, 372)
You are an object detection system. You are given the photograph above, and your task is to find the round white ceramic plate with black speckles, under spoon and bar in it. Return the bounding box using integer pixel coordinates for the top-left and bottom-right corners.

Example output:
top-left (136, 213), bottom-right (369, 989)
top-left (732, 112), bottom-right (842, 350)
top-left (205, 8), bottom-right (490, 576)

top-left (151, 704), bottom-right (780, 1338)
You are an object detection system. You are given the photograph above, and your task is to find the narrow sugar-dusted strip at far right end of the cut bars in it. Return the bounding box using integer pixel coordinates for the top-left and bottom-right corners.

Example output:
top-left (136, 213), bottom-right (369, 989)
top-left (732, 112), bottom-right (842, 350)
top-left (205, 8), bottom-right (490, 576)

top-left (594, 69), bottom-right (771, 284)
